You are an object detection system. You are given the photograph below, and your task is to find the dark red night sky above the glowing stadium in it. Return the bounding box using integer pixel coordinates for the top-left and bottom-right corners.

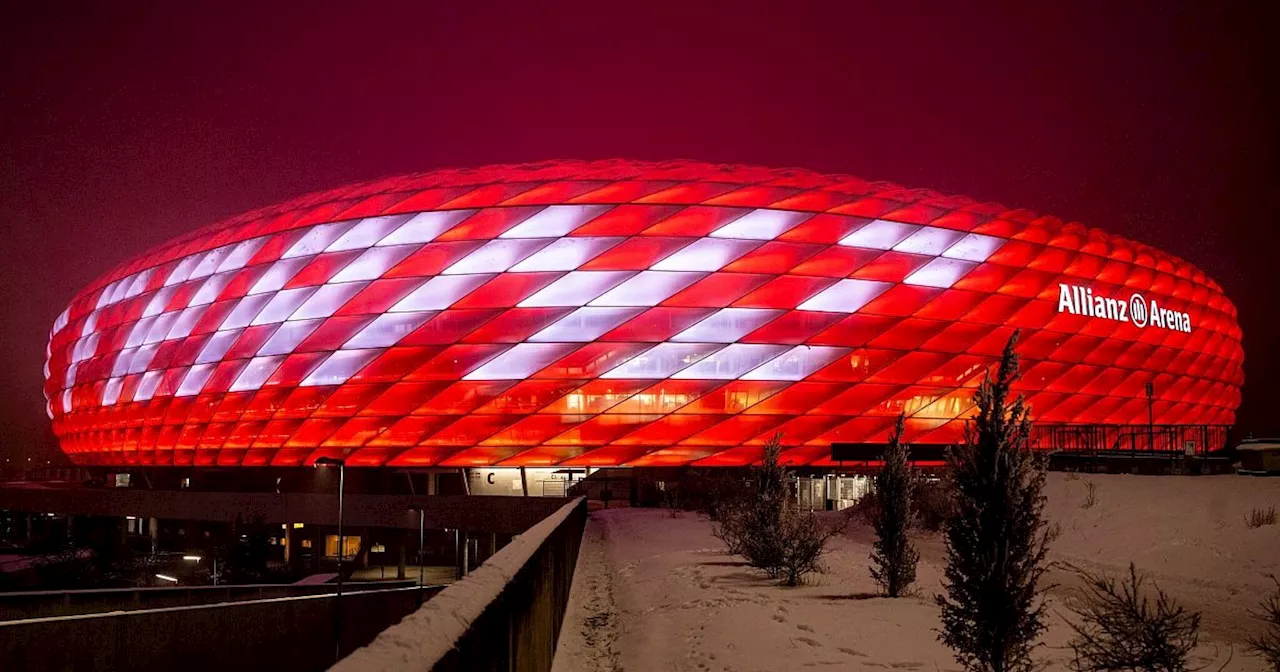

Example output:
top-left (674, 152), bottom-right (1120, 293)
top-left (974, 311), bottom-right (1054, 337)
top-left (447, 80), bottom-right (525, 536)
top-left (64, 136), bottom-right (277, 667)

top-left (0, 0), bottom-right (1280, 461)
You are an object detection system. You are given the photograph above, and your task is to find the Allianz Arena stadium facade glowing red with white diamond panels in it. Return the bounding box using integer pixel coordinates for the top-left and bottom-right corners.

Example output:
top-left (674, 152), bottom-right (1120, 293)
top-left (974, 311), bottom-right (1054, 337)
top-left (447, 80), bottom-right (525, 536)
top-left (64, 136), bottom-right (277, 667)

top-left (45, 161), bottom-right (1244, 467)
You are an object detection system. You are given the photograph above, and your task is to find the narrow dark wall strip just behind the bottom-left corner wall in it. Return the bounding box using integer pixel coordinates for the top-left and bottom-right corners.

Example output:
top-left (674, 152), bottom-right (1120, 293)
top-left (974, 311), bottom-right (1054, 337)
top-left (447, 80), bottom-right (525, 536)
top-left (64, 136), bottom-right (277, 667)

top-left (0, 580), bottom-right (416, 621)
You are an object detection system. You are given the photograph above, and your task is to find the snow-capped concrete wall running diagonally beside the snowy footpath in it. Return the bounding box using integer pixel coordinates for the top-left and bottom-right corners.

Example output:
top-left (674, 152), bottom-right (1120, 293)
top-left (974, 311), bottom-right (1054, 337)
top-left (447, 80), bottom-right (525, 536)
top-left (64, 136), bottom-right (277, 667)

top-left (334, 498), bottom-right (586, 672)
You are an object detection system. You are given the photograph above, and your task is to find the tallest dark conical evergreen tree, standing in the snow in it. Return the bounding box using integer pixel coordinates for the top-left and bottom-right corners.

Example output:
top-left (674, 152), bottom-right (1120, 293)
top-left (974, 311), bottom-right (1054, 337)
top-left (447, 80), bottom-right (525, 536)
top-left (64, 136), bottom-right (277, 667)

top-left (937, 332), bottom-right (1048, 672)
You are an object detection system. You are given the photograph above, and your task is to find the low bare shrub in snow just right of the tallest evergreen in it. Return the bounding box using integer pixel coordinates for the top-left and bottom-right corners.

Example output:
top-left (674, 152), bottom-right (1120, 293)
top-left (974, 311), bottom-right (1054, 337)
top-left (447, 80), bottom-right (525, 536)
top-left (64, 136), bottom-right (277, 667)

top-left (1069, 563), bottom-right (1201, 672)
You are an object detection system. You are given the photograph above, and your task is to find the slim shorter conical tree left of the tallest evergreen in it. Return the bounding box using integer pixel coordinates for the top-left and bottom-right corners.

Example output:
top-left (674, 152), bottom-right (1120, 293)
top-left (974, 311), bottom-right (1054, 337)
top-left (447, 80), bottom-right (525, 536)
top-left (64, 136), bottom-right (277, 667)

top-left (872, 415), bottom-right (920, 598)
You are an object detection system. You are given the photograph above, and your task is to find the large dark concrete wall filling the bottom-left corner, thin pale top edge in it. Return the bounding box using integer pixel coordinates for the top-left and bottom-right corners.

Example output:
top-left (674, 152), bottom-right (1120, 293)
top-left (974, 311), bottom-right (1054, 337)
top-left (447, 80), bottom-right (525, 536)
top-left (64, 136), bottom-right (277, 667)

top-left (0, 586), bottom-right (440, 672)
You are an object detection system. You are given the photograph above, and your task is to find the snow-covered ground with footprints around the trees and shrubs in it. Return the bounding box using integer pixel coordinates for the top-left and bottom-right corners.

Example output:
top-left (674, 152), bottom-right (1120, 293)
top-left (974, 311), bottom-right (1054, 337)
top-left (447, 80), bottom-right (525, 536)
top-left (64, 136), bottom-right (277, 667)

top-left (554, 474), bottom-right (1280, 672)
